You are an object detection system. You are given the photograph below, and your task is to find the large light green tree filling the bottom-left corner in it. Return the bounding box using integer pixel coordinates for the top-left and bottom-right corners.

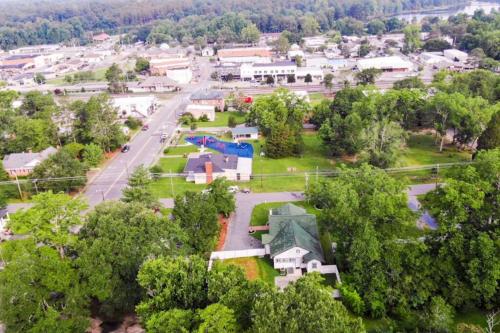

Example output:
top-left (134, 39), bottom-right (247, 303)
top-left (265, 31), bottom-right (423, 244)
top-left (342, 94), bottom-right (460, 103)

top-left (0, 239), bottom-right (90, 332)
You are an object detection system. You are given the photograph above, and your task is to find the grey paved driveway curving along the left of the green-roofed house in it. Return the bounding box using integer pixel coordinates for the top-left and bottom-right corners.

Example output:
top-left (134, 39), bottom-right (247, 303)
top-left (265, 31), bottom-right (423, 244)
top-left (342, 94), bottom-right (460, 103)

top-left (224, 192), bottom-right (304, 251)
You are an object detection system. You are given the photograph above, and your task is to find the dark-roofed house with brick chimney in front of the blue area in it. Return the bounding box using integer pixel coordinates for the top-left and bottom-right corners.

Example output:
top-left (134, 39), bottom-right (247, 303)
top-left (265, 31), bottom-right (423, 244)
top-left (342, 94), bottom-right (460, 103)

top-left (184, 153), bottom-right (252, 184)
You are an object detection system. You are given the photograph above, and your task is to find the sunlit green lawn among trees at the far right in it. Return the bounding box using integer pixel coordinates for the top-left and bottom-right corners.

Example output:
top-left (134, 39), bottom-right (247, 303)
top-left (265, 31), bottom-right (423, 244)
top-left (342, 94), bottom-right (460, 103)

top-left (400, 134), bottom-right (471, 166)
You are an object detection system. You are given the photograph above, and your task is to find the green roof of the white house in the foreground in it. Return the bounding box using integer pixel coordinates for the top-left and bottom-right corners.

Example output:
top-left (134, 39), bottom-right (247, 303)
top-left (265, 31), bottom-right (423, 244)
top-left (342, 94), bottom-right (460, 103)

top-left (262, 204), bottom-right (325, 262)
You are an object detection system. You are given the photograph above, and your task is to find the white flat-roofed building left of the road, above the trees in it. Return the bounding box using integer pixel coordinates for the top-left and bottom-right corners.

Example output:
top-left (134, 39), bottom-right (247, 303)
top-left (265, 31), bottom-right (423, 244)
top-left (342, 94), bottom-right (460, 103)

top-left (111, 95), bottom-right (156, 119)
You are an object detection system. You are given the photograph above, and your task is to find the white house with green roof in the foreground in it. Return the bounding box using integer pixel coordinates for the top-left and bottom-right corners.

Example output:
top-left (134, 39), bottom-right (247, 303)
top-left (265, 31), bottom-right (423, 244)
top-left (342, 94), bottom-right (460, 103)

top-left (262, 203), bottom-right (326, 273)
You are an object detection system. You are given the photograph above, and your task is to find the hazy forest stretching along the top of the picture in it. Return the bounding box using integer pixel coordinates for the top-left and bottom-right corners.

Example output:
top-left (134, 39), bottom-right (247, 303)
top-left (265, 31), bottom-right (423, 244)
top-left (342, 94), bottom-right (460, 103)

top-left (0, 0), bottom-right (472, 49)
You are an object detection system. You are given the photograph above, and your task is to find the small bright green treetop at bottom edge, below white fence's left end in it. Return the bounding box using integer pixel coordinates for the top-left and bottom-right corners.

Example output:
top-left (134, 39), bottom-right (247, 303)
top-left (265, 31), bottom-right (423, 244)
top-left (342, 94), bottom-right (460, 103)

top-left (198, 303), bottom-right (239, 333)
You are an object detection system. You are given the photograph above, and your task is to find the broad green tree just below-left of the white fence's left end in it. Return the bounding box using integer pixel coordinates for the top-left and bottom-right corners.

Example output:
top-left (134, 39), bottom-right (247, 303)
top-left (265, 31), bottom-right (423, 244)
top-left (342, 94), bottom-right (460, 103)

top-left (136, 256), bottom-right (208, 323)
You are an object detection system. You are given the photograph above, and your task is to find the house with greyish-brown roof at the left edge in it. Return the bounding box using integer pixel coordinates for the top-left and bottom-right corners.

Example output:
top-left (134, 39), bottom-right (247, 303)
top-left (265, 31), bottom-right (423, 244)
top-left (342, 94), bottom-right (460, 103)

top-left (3, 147), bottom-right (57, 177)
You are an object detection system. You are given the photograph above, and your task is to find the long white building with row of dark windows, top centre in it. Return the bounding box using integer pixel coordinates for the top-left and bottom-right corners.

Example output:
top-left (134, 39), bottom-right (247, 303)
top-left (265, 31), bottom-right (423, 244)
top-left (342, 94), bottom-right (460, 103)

top-left (240, 61), bottom-right (297, 82)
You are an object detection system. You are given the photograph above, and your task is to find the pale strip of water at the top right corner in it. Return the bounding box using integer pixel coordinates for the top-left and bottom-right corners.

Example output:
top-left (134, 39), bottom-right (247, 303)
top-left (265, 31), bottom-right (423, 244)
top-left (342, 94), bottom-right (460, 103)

top-left (395, 1), bottom-right (500, 22)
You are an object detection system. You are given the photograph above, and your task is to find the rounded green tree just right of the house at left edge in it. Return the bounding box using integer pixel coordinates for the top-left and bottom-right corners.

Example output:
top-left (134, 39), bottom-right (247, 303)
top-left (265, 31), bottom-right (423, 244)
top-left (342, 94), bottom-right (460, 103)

top-left (30, 150), bottom-right (87, 193)
